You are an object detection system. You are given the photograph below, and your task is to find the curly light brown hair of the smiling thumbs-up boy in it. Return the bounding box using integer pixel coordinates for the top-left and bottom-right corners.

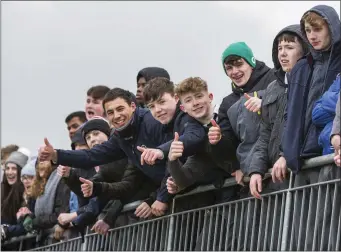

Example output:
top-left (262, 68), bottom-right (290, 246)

top-left (175, 77), bottom-right (208, 97)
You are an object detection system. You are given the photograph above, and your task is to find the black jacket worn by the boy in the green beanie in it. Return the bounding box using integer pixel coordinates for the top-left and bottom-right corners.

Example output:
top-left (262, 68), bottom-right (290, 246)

top-left (212, 60), bottom-right (276, 168)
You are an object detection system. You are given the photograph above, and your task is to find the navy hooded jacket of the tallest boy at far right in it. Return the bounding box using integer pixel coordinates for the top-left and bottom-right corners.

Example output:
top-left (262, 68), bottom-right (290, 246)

top-left (282, 5), bottom-right (341, 172)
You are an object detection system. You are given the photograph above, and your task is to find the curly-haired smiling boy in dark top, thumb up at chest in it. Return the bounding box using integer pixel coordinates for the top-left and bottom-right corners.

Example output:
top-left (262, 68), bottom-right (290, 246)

top-left (167, 77), bottom-right (234, 194)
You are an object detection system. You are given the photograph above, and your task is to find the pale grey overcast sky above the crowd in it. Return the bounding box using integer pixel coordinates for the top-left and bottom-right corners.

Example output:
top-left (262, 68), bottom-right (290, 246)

top-left (1, 1), bottom-right (340, 156)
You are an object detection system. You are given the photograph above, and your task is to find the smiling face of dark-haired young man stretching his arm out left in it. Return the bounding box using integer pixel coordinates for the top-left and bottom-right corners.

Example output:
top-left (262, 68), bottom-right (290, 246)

top-left (104, 97), bottom-right (136, 129)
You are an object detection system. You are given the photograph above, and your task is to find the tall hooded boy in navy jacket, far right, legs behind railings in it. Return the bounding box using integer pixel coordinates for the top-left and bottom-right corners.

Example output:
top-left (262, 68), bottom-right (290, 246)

top-left (282, 5), bottom-right (341, 250)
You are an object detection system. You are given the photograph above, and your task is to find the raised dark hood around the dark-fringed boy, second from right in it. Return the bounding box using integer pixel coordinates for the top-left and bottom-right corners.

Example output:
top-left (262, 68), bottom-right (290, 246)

top-left (272, 24), bottom-right (309, 70)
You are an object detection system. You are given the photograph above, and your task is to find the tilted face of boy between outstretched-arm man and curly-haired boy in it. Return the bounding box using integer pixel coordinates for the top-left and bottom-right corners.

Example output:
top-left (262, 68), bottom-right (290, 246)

top-left (148, 93), bottom-right (179, 124)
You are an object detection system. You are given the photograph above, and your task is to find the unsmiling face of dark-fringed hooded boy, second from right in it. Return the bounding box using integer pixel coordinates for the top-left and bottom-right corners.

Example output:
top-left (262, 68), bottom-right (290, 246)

top-left (278, 36), bottom-right (303, 72)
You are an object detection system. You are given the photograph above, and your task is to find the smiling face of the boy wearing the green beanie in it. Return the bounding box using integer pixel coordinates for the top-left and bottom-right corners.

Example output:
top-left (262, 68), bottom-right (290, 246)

top-left (224, 58), bottom-right (253, 87)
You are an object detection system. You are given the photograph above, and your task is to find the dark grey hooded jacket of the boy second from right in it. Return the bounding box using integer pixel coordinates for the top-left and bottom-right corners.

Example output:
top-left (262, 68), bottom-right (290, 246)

top-left (246, 24), bottom-right (308, 176)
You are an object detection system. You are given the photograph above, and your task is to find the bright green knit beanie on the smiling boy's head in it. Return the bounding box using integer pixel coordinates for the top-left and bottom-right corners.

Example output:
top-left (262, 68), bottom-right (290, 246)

top-left (221, 42), bottom-right (256, 67)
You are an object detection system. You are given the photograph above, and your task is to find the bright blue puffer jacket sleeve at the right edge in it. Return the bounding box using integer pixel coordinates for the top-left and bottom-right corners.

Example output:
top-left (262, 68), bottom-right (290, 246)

top-left (312, 74), bottom-right (340, 155)
